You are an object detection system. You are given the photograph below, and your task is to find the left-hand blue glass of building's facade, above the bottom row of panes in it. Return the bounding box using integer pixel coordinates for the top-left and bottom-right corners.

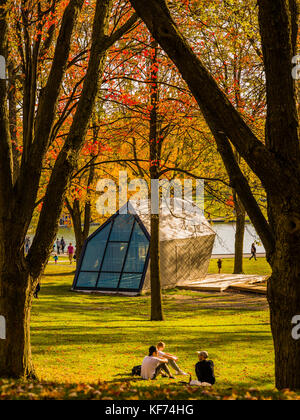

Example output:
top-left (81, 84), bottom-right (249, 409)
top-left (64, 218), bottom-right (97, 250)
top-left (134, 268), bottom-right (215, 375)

top-left (81, 223), bottom-right (111, 271)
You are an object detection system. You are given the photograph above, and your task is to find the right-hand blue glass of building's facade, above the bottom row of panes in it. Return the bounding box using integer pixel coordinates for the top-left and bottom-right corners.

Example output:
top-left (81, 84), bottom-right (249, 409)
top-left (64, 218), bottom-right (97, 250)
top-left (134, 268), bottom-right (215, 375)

top-left (124, 223), bottom-right (149, 273)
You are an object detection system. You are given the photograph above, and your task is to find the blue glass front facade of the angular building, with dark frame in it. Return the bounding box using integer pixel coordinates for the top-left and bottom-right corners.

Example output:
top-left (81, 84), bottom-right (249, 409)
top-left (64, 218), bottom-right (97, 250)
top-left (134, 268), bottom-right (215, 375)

top-left (73, 212), bottom-right (150, 292)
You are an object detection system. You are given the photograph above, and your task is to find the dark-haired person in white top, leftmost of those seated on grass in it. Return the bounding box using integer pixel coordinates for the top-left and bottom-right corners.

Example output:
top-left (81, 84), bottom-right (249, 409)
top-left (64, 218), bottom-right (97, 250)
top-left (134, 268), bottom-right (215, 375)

top-left (141, 346), bottom-right (174, 380)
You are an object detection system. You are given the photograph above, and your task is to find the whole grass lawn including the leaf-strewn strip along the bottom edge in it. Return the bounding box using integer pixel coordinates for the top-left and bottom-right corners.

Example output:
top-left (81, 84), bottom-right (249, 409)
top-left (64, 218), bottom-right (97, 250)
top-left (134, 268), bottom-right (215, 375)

top-left (0, 261), bottom-right (296, 399)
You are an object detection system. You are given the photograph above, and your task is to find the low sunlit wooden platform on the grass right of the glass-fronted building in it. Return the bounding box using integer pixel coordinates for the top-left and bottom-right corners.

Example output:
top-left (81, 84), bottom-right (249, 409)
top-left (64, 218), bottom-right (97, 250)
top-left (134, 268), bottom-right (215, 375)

top-left (178, 274), bottom-right (267, 295)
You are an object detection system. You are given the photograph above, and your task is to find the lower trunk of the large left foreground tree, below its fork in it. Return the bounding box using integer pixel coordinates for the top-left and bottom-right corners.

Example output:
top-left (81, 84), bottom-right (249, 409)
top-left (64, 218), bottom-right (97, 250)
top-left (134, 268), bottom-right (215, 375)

top-left (0, 257), bottom-right (35, 378)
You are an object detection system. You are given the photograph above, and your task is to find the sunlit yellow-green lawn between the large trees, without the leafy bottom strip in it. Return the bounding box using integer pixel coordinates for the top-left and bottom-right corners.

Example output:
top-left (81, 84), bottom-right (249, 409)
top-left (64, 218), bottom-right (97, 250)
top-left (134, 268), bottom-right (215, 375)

top-left (32, 265), bottom-right (274, 389)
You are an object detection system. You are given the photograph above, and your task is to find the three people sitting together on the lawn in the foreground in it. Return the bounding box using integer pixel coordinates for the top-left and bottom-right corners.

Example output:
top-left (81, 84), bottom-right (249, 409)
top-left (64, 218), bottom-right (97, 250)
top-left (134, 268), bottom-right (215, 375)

top-left (141, 341), bottom-right (216, 385)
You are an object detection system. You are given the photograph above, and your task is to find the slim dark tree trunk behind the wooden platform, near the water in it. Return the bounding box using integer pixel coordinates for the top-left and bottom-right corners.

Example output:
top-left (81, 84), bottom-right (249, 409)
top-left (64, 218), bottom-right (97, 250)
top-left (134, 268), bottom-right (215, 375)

top-left (233, 192), bottom-right (246, 274)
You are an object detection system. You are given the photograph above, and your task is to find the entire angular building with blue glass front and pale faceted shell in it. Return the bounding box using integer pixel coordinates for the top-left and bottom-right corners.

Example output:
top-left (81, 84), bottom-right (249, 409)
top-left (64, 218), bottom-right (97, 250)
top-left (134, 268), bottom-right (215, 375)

top-left (72, 198), bottom-right (215, 295)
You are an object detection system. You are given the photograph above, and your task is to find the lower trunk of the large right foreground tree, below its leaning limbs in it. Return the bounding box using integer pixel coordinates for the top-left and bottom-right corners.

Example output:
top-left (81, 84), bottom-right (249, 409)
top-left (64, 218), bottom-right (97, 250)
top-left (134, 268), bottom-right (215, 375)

top-left (268, 191), bottom-right (300, 390)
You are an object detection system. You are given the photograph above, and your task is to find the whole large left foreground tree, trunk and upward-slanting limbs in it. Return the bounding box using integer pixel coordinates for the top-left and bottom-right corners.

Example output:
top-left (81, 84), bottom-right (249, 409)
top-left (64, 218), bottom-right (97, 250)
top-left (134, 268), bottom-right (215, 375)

top-left (0, 0), bottom-right (137, 378)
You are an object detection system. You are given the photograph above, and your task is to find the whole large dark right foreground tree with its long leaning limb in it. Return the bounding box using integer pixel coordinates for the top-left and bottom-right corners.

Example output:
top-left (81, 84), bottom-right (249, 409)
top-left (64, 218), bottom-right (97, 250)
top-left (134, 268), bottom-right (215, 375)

top-left (131, 0), bottom-right (300, 389)
